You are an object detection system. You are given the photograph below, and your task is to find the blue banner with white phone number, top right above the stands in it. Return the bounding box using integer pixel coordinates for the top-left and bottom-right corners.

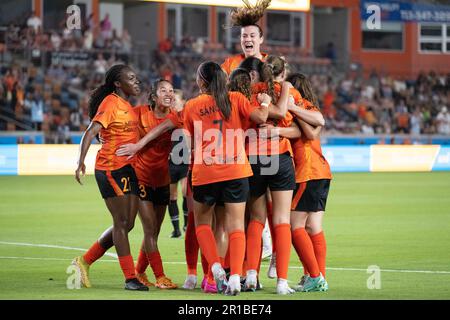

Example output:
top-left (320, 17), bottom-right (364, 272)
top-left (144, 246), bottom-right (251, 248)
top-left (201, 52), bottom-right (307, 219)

top-left (360, 0), bottom-right (450, 23)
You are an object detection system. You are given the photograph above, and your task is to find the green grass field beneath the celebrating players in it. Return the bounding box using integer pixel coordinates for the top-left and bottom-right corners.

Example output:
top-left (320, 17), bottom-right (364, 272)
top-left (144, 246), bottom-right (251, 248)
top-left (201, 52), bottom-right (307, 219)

top-left (0, 173), bottom-right (450, 301)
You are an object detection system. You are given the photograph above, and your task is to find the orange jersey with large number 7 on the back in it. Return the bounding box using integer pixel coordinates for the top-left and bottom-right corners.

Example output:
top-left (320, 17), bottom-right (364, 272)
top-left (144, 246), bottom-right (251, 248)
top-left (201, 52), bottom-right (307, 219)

top-left (184, 92), bottom-right (256, 186)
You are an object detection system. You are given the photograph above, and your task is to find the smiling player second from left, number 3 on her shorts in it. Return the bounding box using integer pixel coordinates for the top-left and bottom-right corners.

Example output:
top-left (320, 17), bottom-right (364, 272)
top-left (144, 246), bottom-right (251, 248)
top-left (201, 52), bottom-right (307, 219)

top-left (116, 80), bottom-right (182, 289)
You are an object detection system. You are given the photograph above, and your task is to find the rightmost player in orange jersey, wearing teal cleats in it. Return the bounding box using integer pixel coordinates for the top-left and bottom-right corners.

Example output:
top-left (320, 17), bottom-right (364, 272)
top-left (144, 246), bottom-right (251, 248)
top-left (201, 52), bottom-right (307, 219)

top-left (288, 74), bottom-right (332, 292)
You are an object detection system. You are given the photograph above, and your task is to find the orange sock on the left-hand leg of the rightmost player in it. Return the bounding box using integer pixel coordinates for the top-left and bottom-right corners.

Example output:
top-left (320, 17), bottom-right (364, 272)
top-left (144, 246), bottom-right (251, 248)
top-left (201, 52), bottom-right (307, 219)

top-left (292, 228), bottom-right (320, 278)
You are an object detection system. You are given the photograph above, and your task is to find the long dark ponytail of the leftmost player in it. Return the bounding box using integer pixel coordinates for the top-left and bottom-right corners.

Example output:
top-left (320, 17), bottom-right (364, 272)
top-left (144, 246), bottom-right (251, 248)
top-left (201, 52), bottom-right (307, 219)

top-left (88, 64), bottom-right (129, 120)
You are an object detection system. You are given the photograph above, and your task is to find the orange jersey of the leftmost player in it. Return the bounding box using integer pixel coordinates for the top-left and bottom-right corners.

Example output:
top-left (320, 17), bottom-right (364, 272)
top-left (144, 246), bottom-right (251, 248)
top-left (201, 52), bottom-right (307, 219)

top-left (92, 93), bottom-right (139, 170)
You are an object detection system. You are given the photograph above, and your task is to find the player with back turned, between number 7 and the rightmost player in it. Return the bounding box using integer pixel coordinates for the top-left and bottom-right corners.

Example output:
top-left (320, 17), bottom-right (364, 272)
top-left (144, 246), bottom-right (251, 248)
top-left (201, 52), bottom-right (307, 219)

top-left (241, 56), bottom-right (300, 294)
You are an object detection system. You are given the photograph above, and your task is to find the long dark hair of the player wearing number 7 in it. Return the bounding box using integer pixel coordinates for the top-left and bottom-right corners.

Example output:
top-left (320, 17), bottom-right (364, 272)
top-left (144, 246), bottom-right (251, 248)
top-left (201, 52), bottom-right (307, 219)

top-left (197, 61), bottom-right (231, 120)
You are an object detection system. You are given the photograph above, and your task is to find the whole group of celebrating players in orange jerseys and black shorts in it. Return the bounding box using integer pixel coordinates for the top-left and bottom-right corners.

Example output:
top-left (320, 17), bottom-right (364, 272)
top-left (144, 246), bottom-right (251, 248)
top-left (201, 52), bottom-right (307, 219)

top-left (73, 0), bottom-right (332, 295)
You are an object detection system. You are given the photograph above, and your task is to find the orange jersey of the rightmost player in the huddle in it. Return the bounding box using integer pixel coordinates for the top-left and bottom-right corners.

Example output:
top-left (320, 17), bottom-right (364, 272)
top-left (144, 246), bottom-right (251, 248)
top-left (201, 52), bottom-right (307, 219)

top-left (292, 99), bottom-right (332, 183)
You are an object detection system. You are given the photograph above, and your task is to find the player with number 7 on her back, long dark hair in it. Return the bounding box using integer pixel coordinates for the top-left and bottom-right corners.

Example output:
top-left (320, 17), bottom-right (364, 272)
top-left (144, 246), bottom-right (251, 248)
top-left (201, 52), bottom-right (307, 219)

top-left (184, 62), bottom-right (270, 295)
